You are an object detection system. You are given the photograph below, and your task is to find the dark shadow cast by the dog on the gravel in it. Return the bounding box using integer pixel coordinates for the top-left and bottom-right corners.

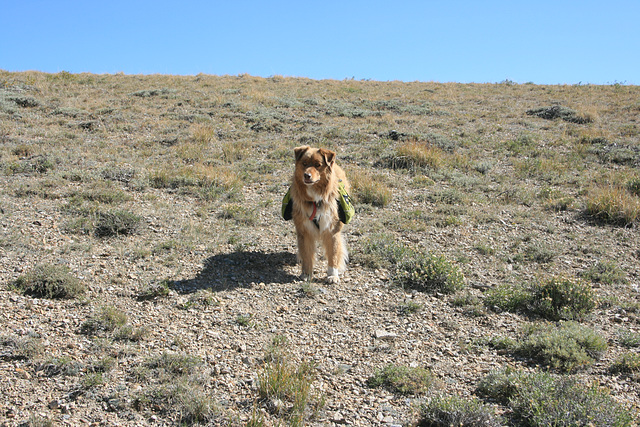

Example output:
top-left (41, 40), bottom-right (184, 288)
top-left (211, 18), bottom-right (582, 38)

top-left (172, 251), bottom-right (297, 294)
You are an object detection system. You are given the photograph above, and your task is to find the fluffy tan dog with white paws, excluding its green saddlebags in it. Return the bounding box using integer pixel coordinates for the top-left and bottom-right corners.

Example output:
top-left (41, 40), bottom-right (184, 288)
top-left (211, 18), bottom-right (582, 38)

top-left (291, 145), bottom-right (349, 283)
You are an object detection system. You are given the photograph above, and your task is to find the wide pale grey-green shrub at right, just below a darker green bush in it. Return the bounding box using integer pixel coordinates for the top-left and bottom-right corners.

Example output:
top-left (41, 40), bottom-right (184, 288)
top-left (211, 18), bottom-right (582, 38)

top-left (510, 321), bottom-right (607, 372)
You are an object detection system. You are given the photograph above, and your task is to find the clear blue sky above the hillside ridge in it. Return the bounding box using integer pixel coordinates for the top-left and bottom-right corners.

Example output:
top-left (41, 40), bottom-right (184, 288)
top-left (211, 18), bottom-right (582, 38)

top-left (0, 0), bottom-right (640, 85)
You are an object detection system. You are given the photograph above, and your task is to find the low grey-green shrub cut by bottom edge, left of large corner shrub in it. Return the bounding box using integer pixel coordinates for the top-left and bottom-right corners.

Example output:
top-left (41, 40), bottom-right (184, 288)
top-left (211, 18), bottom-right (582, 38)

top-left (417, 394), bottom-right (504, 427)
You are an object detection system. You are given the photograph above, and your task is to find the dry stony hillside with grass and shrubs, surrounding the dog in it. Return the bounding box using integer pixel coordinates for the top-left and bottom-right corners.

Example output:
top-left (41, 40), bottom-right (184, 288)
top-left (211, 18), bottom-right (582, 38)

top-left (0, 71), bottom-right (640, 425)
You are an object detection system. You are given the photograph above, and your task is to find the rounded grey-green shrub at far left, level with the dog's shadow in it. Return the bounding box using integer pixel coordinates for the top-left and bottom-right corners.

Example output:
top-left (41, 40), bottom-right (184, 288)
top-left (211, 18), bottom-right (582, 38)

top-left (13, 264), bottom-right (86, 298)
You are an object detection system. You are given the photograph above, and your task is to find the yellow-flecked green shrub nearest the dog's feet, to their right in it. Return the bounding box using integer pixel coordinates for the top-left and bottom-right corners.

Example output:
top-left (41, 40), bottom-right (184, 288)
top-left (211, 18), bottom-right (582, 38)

top-left (394, 253), bottom-right (464, 294)
